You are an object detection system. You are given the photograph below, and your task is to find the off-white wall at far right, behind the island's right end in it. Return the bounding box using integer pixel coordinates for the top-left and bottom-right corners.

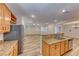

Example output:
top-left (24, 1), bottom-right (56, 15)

top-left (63, 24), bottom-right (79, 38)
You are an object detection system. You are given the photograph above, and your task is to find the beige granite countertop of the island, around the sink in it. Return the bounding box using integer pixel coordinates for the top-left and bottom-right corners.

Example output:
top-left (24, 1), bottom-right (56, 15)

top-left (43, 37), bottom-right (72, 44)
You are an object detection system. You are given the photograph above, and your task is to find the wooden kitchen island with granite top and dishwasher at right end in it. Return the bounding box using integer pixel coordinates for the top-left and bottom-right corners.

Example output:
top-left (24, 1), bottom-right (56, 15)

top-left (42, 37), bottom-right (72, 56)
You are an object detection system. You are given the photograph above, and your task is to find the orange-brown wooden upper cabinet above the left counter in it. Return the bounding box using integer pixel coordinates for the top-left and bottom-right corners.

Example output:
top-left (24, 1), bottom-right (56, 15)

top-left (0, 3), bottom-right (16, 33)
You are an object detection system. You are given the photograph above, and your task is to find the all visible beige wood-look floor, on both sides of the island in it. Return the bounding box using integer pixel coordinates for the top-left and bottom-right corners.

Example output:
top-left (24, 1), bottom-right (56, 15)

top-left (21, 35), bottom-right (79, 56)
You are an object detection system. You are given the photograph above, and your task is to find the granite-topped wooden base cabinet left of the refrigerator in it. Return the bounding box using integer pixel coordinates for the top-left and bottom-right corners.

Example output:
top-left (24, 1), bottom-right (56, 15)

top-left (0, 40), bottom-right (18, 56)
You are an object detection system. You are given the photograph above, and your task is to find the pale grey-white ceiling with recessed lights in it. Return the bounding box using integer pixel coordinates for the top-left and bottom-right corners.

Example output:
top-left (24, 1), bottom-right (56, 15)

top-left (7, 3), bottom-right (79, 24)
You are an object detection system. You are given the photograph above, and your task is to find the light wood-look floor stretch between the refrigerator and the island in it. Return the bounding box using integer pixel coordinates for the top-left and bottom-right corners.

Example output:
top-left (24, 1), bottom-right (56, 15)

top-left (21, 35), bottom-right (41, 56)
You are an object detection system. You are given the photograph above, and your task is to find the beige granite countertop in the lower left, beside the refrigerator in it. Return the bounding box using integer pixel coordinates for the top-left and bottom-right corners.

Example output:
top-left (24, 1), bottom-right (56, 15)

top-left (0, 40), bottom-right (18, 56)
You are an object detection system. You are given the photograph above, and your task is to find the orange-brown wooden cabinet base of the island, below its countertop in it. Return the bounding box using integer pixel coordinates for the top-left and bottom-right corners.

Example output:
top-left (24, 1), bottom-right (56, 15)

top-left (42, 40), bottom-right (69, 56)
